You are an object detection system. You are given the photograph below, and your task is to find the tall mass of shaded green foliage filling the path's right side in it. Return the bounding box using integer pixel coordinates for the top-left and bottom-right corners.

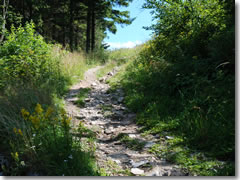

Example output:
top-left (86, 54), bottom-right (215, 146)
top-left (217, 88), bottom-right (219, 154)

top-left (112, 0), bottom-right (235, 175)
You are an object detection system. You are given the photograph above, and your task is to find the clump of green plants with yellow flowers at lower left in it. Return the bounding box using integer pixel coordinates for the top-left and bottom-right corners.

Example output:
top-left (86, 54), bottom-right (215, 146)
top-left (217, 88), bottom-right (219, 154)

top-left (4, 104), bottom-right (98, 176)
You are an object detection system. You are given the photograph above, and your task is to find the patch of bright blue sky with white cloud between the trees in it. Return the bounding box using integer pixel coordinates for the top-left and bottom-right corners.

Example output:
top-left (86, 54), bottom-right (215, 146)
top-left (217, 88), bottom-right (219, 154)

top-left (104, 0), bottom-right (155, 49)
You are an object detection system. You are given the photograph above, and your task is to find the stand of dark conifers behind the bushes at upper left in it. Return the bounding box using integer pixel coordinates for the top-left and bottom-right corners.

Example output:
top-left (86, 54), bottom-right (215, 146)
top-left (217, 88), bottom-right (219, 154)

top-left (0, 0), bottom-right (133, 52)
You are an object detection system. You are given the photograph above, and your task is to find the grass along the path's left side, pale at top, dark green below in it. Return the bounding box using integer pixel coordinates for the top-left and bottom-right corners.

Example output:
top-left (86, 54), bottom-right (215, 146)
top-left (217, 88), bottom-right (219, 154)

top-left (0, 40), bottom-right (102, 176)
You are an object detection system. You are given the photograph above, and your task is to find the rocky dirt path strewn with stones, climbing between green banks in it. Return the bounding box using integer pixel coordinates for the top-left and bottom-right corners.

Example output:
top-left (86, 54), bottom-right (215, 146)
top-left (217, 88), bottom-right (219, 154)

top-left (65, 66), bottom-right (185, 176)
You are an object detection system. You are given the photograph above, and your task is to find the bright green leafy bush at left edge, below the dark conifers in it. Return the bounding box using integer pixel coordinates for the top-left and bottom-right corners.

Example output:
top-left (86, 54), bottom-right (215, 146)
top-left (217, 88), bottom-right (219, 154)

top-left (0, 23), bottom-right (69, 94)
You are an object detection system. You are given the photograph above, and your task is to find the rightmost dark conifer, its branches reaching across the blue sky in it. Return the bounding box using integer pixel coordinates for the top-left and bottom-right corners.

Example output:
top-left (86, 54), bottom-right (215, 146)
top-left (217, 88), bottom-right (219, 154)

top-left (86, 0), bottom-right (134, 53)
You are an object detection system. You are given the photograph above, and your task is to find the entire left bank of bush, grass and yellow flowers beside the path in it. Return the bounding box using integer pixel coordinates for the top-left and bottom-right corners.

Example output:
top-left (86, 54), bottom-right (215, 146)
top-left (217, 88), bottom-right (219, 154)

top-left (0, 23), bottom-right (99, 175)
